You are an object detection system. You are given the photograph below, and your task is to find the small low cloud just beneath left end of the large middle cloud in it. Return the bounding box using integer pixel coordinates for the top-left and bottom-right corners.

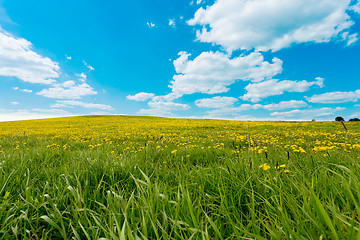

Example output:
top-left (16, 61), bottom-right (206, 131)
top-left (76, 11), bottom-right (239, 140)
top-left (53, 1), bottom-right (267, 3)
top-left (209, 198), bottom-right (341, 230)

top-left (138, 101), bottom-right (190, 117)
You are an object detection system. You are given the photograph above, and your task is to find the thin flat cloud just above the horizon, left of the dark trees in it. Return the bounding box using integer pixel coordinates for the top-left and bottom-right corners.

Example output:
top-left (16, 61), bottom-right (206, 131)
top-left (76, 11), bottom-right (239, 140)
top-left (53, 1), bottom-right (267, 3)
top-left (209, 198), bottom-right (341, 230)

top-left (270, 107), bottom-right (345, 120)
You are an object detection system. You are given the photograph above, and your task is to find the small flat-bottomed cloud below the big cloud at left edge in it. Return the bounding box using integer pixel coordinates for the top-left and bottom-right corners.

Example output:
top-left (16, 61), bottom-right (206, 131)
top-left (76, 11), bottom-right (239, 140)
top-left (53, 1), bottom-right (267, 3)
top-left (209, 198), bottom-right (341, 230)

top-left (36, 81), bottom-right (97, 99)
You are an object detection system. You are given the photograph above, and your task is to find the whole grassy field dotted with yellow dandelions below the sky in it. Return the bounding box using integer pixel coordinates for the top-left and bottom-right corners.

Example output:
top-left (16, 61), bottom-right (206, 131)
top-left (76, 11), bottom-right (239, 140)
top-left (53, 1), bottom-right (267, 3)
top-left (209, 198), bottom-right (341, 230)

top-left (0, 116), bottom-right (360, 239)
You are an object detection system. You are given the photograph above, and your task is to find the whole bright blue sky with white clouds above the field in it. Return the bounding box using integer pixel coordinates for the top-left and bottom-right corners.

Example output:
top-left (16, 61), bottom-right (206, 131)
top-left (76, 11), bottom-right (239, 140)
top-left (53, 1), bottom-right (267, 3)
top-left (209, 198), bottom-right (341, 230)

top-left (0, 0), bottom-right (360, 121)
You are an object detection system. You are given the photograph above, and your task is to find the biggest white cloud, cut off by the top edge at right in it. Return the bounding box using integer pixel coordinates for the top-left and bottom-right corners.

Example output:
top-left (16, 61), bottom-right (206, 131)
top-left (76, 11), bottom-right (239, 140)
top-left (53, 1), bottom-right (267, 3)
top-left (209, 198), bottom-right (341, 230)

top-left (188, 0), bottom-right (358, 51)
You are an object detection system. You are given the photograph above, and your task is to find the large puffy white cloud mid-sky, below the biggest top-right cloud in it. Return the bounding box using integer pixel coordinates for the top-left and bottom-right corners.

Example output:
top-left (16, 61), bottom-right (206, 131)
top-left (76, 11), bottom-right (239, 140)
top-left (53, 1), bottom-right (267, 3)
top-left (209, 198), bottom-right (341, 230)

top-left (169, 52), bottom-right (282, 96)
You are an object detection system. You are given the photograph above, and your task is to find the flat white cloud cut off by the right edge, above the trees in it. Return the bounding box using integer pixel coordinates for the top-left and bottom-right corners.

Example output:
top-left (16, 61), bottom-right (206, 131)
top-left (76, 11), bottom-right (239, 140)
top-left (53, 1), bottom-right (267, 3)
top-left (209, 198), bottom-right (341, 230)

top-left (306, 90), bottom-right (360, 103)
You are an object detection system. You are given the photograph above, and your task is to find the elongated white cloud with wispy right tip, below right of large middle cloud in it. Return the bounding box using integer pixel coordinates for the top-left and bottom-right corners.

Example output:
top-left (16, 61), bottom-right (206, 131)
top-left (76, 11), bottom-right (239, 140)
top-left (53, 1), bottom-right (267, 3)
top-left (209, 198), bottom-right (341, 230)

top-left (241, 78), bottom-right (324, 102)
